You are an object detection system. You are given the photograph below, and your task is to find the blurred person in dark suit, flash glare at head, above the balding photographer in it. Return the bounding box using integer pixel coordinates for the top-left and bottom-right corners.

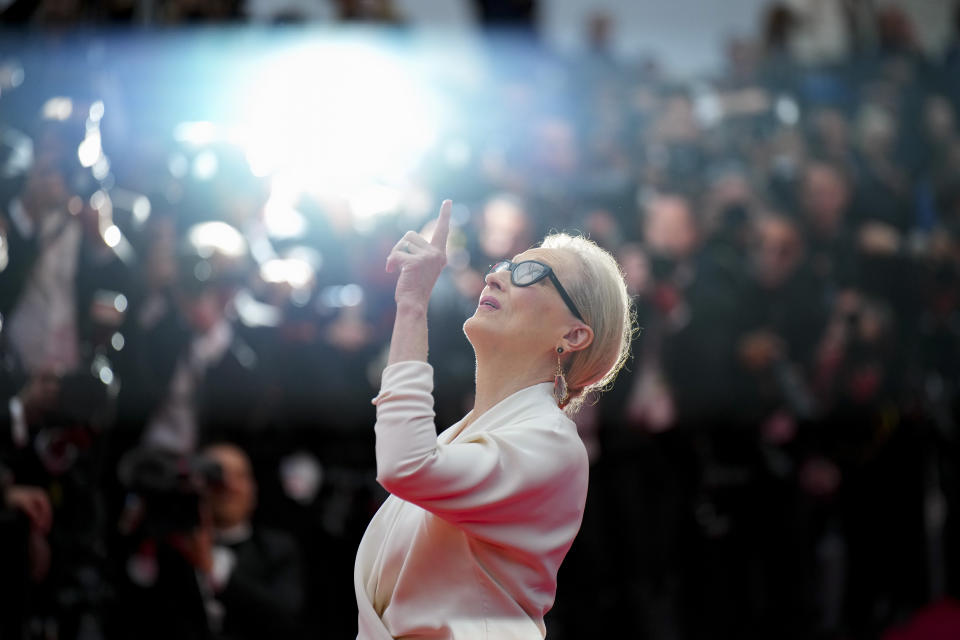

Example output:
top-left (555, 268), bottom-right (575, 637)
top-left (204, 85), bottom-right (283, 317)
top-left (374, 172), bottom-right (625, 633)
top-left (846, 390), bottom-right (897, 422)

top-left (116, 222), bottom-right (263, 455)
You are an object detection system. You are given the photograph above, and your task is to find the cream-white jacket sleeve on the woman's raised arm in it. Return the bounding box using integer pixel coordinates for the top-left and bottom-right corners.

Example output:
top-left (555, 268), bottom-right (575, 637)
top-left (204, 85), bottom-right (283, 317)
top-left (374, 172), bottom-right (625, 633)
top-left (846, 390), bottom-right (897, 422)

top-left (374, 361), bottom-right (587, 530)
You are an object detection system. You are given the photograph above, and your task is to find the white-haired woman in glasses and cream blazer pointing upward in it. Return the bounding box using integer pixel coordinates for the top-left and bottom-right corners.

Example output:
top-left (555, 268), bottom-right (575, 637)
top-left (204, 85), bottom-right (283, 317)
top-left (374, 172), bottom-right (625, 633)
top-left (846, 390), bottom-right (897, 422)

top-left (354, 200), bottom-right (632, 640)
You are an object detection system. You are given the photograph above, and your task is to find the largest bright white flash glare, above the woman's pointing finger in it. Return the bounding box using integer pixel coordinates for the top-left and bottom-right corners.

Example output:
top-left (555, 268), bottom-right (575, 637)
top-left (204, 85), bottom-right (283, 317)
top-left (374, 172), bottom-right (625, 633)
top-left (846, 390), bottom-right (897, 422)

top-left (241, 39), bottom-right (439, 194)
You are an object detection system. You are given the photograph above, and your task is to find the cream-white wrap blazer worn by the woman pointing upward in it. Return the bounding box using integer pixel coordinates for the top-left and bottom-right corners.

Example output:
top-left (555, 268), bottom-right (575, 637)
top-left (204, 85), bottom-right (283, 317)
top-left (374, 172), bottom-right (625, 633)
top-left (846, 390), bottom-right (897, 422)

top-left (354, 361), bottom-right (588, 640)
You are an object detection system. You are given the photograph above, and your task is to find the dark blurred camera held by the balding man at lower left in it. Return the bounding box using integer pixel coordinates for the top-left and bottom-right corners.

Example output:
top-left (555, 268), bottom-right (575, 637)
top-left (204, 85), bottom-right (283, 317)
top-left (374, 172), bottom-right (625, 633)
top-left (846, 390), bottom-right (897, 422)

top-left (118, 447), bottom-right (223, 538)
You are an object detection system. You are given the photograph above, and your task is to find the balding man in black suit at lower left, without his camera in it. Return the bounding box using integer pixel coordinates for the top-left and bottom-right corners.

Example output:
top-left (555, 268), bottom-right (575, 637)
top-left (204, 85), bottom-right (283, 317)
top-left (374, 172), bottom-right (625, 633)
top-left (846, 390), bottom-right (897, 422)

top-left (108, 443), bottom-right (303, 640)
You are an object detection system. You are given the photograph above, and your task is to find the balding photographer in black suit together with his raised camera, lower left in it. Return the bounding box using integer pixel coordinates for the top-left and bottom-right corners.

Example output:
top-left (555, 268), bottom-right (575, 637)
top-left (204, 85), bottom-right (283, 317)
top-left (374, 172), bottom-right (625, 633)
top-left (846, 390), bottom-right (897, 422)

top-left (109, 444), bottom-right (303, 640)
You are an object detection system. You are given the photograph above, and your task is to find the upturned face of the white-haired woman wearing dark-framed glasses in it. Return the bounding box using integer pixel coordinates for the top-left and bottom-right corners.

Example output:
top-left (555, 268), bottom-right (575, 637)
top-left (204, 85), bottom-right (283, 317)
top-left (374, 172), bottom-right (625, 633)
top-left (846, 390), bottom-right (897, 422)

top-left (463, 248), bottom-right (582, 362)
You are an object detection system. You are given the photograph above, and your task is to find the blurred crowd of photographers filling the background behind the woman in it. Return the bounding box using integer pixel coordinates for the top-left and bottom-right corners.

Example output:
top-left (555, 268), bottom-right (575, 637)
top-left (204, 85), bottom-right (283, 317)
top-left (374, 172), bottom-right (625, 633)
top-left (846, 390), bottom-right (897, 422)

top-left (0, 2), bottom-right (960, 640)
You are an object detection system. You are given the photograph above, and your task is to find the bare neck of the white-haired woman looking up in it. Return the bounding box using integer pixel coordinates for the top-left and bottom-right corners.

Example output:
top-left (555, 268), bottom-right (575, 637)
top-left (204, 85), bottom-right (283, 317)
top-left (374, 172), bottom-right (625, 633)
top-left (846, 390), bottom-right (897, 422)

top-left (468, 350), bottom-right (553, 422)
